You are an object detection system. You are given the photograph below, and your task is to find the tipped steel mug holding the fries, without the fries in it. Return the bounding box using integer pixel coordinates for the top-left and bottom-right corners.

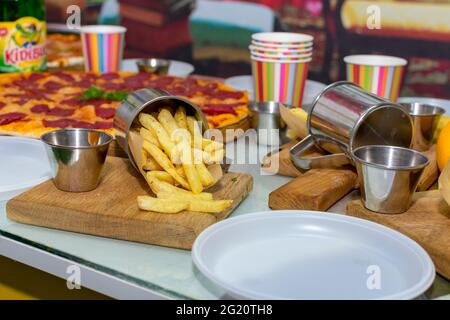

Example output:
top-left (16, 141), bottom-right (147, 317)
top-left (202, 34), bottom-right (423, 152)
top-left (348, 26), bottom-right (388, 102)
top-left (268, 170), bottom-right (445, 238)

top-left (114, 89), bottom-right (208, 170)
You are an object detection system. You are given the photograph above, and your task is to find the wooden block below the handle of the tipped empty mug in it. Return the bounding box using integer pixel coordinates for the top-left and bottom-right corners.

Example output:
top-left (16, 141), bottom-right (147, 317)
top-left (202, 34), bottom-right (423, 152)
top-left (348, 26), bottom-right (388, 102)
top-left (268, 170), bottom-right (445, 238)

top-left (269, 169), bottom-right (357, 211)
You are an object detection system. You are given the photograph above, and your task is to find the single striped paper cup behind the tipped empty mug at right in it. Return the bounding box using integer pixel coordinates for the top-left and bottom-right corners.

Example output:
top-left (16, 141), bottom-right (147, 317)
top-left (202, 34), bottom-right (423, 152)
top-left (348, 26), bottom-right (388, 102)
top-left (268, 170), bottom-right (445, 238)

top-left (344, 55), bottom-right (408, 102)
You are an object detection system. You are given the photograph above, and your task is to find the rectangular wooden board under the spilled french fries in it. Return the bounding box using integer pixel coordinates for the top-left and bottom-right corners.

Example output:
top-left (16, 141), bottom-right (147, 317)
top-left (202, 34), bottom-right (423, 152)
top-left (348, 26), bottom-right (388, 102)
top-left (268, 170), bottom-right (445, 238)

top-left (6, 157), bottom-right (253, 249)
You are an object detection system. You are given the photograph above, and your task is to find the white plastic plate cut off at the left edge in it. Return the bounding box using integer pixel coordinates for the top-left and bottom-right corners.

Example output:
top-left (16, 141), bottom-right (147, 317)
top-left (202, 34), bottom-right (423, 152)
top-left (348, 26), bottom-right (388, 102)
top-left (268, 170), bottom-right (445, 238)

top-left (0, 136), bottom-right (51, 201)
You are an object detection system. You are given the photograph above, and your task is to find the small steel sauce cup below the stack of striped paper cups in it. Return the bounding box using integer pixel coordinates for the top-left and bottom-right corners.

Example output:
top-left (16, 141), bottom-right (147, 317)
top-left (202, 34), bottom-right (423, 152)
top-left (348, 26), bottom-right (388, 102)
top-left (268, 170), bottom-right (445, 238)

top-left (248, 101), bottom-right (289, 146)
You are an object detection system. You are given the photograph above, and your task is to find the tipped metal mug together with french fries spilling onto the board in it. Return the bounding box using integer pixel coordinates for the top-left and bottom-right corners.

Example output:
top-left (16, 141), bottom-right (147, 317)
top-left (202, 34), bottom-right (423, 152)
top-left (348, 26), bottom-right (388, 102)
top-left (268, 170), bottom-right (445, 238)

top-left (114, 89), bottom-right (232, 214)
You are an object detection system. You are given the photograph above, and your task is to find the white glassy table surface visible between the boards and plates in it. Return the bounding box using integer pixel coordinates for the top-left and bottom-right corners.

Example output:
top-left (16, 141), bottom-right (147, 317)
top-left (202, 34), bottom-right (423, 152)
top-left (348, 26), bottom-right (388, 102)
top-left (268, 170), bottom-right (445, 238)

top-left (0, 138), bottom-right (450, 299)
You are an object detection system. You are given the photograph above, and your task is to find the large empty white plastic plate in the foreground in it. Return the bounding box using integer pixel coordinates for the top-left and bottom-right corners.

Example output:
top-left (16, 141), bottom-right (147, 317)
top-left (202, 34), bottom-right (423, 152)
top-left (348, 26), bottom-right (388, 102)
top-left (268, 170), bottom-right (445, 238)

top-left (192, 210), bottom-right (435, 299)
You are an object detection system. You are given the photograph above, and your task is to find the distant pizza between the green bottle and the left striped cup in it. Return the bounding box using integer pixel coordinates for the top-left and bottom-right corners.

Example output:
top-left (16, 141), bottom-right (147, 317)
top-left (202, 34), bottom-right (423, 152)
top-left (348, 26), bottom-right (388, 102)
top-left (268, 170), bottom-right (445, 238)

top-left (45, 33), bottom-right (84, 69)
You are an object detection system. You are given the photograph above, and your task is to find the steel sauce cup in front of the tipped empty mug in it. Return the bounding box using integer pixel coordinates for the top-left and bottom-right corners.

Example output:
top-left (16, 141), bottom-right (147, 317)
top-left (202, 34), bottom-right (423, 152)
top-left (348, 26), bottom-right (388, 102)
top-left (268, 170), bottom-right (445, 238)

top-left (352, 145), bottom-right (428, 213)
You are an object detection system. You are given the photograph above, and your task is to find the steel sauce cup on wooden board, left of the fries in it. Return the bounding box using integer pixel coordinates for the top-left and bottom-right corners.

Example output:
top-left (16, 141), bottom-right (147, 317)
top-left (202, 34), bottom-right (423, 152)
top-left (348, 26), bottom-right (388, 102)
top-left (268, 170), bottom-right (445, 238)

top-left (41, 129), bottom-right (113, 192)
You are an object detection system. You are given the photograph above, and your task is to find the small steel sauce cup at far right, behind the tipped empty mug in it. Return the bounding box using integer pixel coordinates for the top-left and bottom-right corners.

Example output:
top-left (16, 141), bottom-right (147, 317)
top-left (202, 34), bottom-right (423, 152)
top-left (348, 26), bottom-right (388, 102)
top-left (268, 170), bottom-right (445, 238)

top-left (401, 102), bottom-right (445, 151)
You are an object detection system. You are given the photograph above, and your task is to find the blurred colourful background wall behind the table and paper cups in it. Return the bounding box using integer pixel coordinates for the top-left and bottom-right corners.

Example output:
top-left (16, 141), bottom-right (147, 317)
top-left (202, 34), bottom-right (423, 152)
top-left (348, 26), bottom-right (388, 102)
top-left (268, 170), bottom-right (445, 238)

top-left (46, 0), bottom-right (450, 98)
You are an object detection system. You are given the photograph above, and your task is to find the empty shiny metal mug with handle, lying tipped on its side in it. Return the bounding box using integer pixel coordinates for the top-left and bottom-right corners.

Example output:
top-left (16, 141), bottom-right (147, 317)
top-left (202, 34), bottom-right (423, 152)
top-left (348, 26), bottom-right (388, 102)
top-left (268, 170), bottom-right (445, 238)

top-left (290, 81), bottom-right (414, 170)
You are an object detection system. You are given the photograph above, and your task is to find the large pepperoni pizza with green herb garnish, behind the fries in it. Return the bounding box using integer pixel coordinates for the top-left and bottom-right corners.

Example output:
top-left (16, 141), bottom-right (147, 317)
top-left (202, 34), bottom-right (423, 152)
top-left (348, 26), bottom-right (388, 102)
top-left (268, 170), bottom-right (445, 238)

top-left (0, 71), bottom-right (249, 138)
